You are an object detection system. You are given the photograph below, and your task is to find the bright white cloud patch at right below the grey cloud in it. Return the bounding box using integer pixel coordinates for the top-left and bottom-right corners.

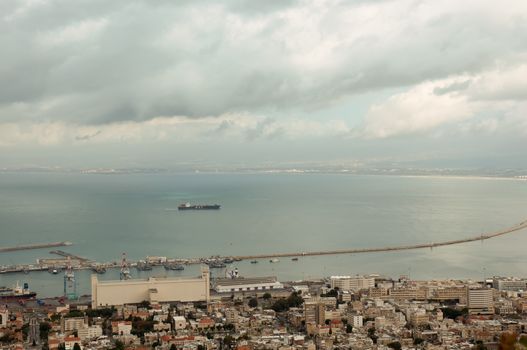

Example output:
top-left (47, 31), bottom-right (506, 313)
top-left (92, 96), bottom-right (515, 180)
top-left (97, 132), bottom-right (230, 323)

top-left (360, 64), bottom-right (527, 138)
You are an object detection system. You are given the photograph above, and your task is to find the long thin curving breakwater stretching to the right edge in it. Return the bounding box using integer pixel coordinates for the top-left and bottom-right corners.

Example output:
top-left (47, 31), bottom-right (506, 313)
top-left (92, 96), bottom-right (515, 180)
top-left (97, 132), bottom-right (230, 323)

top-left (234, 220), bottom-right (527, 260)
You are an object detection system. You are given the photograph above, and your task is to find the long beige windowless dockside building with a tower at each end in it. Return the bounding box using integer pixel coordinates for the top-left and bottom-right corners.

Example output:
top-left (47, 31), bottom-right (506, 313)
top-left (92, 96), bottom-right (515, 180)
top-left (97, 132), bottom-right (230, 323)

top-left (91, 267), bottom-right (210, 309)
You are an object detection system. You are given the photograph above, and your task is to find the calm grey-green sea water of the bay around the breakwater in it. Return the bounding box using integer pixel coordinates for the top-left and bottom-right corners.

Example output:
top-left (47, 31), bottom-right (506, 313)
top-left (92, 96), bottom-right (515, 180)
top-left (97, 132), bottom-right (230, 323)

top-left (0, 173), bottom-right (527, 297)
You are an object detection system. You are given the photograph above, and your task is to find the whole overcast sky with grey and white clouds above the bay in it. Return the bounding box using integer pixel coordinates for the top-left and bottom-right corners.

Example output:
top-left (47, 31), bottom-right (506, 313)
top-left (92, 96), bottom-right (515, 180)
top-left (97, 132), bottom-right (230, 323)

top-left (0, 0), bottom-right (527, 168)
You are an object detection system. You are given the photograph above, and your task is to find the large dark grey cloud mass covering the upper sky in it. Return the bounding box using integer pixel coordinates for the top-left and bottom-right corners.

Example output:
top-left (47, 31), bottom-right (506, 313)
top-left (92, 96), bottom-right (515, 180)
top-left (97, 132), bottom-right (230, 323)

top-left (0, 0), bottom-right (527, 124)
